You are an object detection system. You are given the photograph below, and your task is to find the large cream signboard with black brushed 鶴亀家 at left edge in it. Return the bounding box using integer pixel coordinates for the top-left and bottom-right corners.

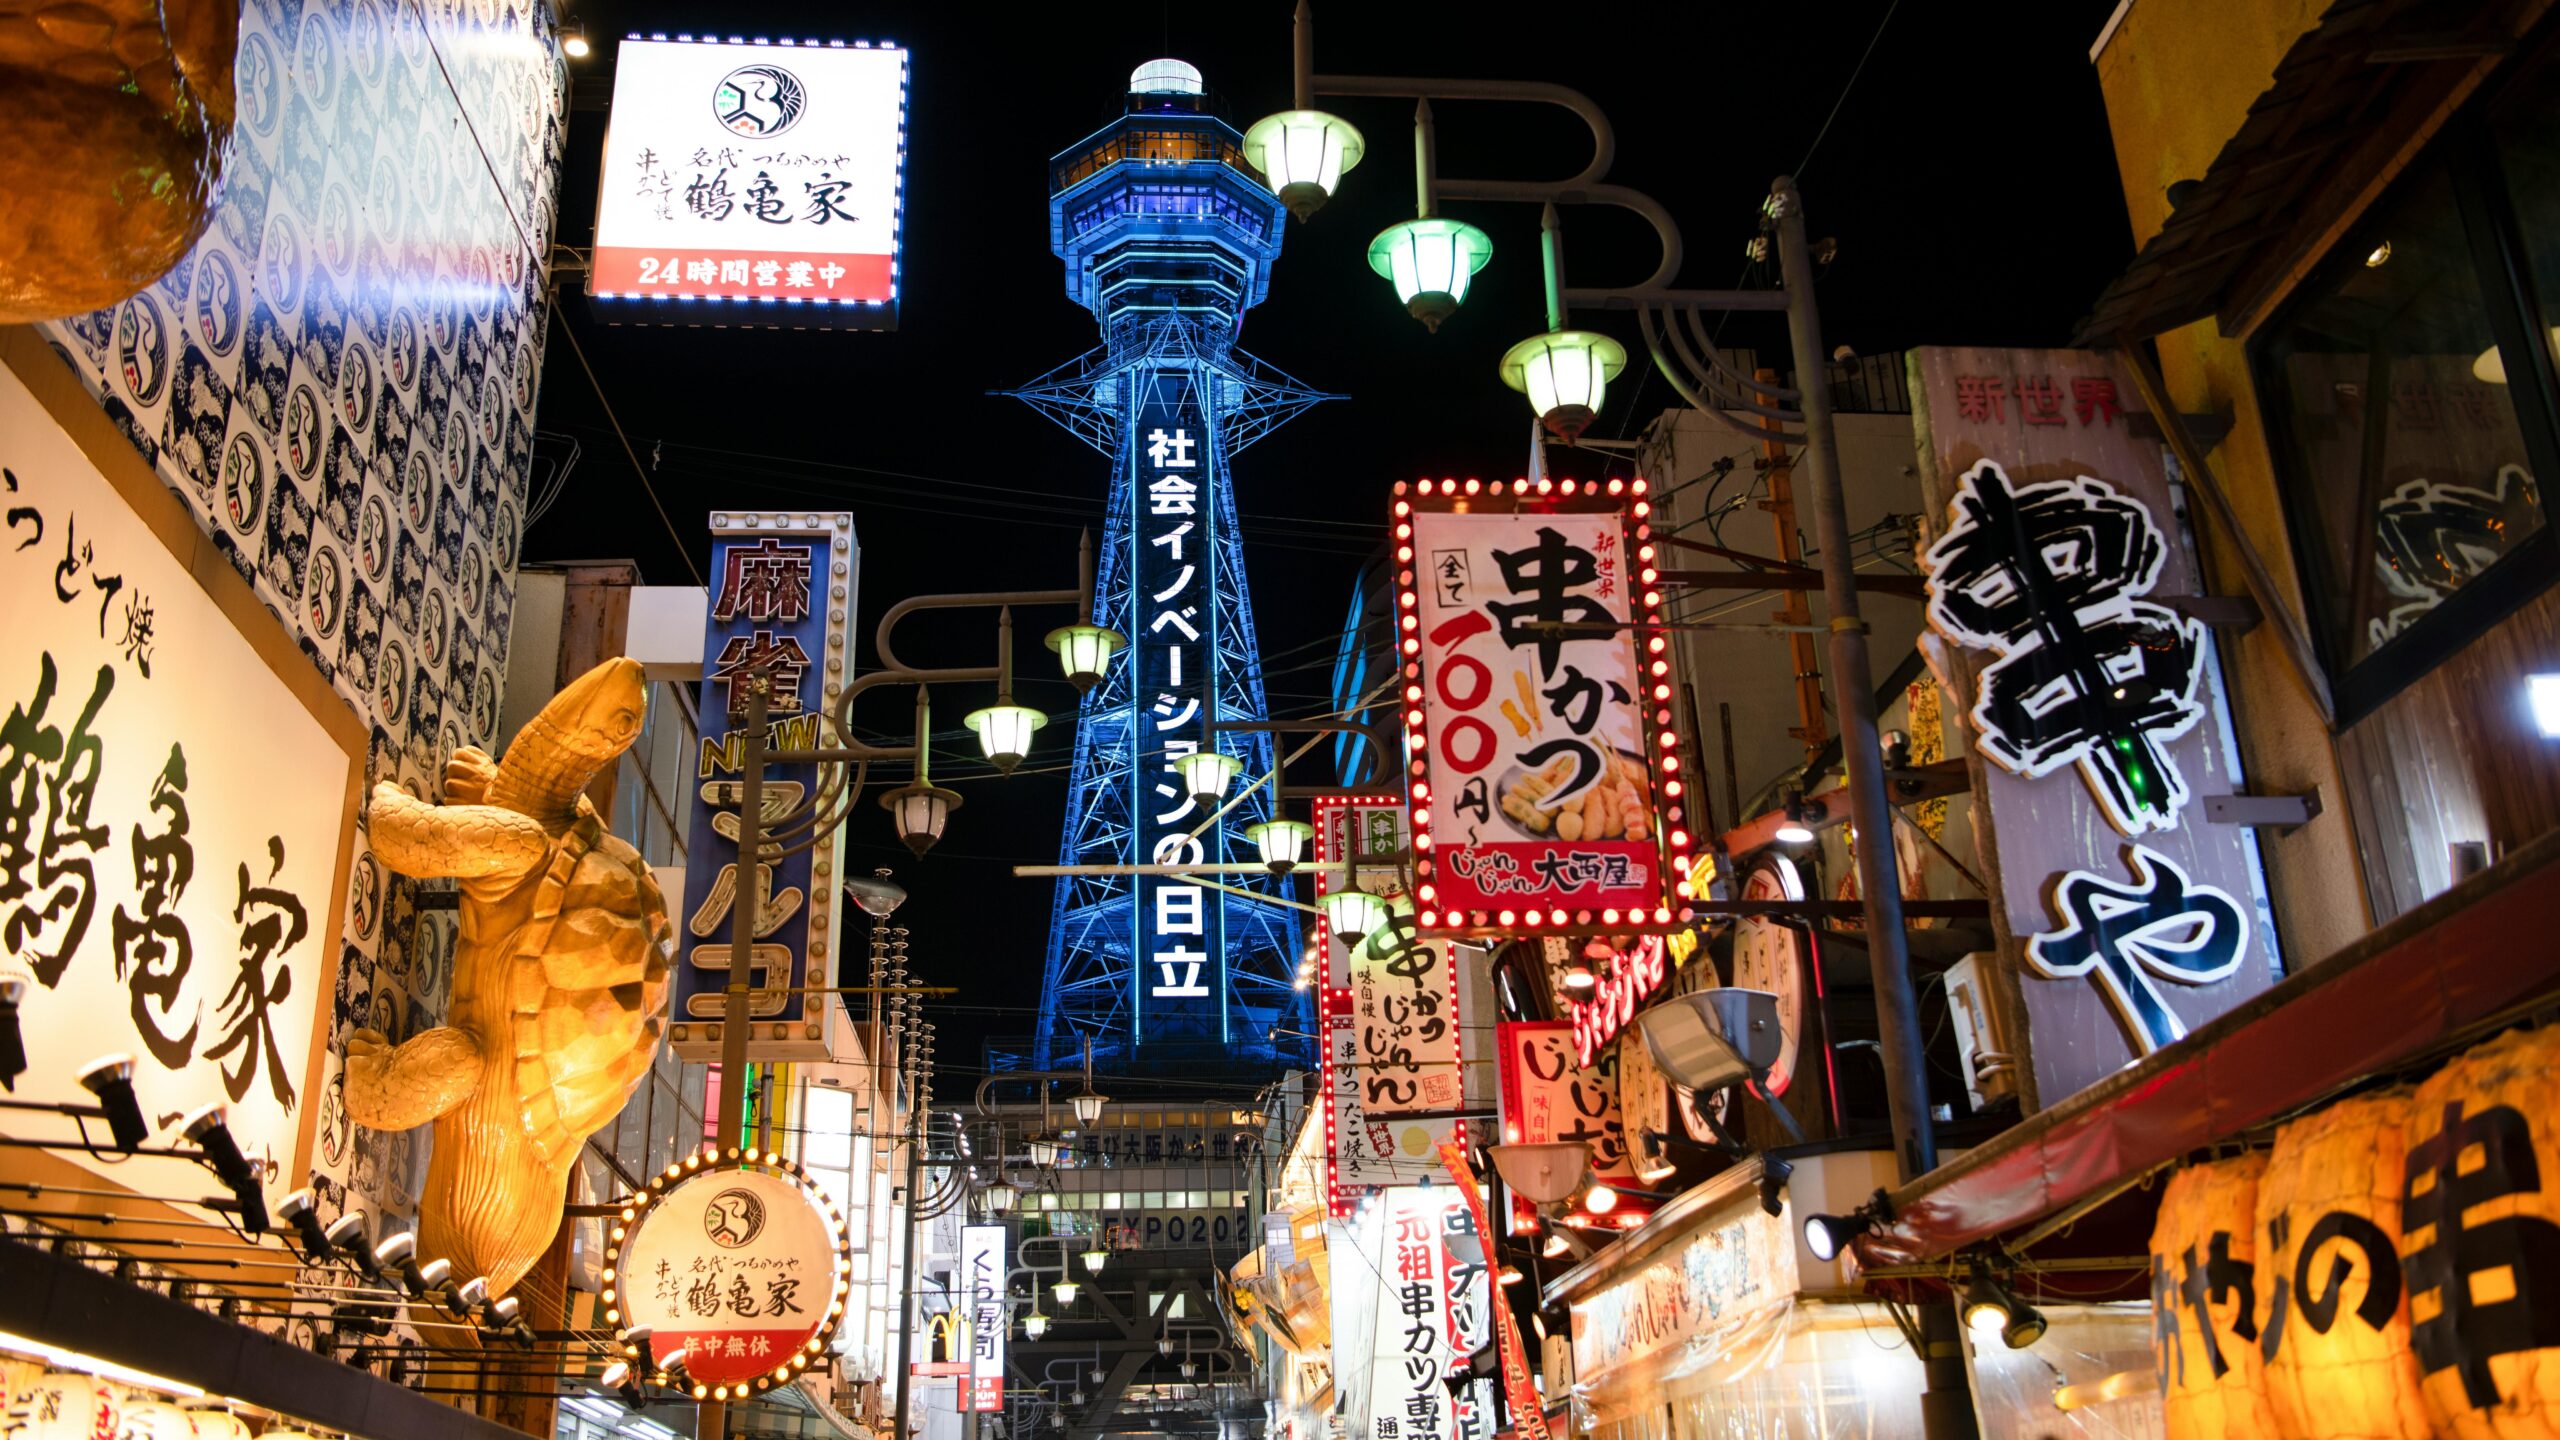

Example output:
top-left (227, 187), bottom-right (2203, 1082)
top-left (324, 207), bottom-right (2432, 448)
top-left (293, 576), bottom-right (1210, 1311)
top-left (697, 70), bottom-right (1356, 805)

top-left (0, 343), bottom-right (371, 1207)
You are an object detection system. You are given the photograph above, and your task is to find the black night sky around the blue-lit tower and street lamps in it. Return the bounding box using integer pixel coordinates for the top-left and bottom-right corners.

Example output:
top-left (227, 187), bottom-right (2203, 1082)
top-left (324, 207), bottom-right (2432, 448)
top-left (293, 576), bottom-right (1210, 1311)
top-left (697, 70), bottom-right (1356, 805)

top-left (525, 0), bottom-right (2132, 1092)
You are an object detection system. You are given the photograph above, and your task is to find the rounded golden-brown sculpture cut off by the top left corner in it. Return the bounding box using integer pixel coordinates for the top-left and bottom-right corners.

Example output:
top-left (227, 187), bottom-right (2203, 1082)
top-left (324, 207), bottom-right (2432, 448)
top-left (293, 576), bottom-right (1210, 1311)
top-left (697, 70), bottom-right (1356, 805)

top-left (0, 0), bottom-right (241, 323)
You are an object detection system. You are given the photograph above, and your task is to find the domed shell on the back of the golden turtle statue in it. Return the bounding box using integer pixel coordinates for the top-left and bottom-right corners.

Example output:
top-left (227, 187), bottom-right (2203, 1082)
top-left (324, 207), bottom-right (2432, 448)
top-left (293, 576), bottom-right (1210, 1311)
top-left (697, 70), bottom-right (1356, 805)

top-left (507, 812), bottom-right (676, 1163)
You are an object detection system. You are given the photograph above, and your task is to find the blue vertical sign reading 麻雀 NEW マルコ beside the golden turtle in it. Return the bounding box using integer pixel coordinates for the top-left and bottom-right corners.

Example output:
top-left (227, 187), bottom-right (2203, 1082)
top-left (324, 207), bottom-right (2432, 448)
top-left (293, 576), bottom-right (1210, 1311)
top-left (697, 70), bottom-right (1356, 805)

top-left (668, 515), bottom-right (855, 1061)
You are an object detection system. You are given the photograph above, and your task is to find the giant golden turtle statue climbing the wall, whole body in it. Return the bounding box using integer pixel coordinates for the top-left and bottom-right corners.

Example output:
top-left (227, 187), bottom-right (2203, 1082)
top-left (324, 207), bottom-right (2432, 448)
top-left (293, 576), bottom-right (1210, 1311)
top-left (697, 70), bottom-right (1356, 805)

top-left (346, 659), bottom-right (676, 1297)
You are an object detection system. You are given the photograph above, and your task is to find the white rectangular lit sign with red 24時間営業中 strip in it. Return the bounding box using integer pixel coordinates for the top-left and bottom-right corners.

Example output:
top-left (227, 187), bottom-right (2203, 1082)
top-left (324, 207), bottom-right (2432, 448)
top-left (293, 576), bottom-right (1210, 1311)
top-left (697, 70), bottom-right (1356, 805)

top-left (586, 38), bottom-right (906, 325)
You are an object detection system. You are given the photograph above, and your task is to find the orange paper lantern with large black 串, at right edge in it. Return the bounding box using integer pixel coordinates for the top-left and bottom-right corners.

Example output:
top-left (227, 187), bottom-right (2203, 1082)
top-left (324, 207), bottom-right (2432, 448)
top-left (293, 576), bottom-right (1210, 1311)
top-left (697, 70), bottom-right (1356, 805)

top-left (2399, 1019), bottom-right (2560, 1440)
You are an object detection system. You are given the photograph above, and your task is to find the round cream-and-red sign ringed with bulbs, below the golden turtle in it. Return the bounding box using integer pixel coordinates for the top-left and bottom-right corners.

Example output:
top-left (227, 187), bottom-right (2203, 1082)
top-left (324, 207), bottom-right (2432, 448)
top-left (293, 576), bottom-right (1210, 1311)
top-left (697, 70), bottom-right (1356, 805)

top-left (604, 1150), bottom-right (852, 1399)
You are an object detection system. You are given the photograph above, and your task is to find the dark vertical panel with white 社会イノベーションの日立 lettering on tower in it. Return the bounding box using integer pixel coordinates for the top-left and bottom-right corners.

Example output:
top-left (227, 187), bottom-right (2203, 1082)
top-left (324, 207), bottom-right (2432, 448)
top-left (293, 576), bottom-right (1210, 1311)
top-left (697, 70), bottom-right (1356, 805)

top-left (1124, 372), bottom-right (1226, 1043)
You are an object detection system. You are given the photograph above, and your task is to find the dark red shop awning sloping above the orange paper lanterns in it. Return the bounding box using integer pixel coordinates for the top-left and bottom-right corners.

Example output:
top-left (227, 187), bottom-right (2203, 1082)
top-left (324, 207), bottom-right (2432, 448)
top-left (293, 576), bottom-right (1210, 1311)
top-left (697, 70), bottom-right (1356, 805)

top-left (1859, 833), bottom-right (2560, 1266)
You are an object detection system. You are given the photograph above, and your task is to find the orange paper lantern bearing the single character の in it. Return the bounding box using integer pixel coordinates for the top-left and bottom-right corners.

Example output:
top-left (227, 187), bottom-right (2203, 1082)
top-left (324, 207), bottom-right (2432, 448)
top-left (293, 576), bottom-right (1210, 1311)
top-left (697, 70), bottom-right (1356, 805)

top-left (2258, 1089), bottom-right (2432, 1440)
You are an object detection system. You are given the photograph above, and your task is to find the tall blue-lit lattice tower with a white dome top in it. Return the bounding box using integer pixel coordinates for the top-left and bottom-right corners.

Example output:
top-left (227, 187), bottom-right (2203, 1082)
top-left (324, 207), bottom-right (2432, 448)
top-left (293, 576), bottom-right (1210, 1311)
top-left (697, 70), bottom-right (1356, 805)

top-left (998, 59), bottom-right (1329, 1074)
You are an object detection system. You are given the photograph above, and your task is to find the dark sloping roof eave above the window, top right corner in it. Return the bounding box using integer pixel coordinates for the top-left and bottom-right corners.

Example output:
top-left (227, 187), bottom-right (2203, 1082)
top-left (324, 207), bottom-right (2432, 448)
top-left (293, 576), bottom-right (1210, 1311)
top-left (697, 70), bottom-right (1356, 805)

top-left (2074, 0), bottom-right (2552, 346)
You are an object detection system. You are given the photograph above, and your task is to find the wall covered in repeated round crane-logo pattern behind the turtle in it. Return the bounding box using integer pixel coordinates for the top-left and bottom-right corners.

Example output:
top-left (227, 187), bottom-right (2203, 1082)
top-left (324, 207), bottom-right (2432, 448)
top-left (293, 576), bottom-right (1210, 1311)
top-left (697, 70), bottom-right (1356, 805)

top-left (46, 0), bottom-right (568, 1217)
